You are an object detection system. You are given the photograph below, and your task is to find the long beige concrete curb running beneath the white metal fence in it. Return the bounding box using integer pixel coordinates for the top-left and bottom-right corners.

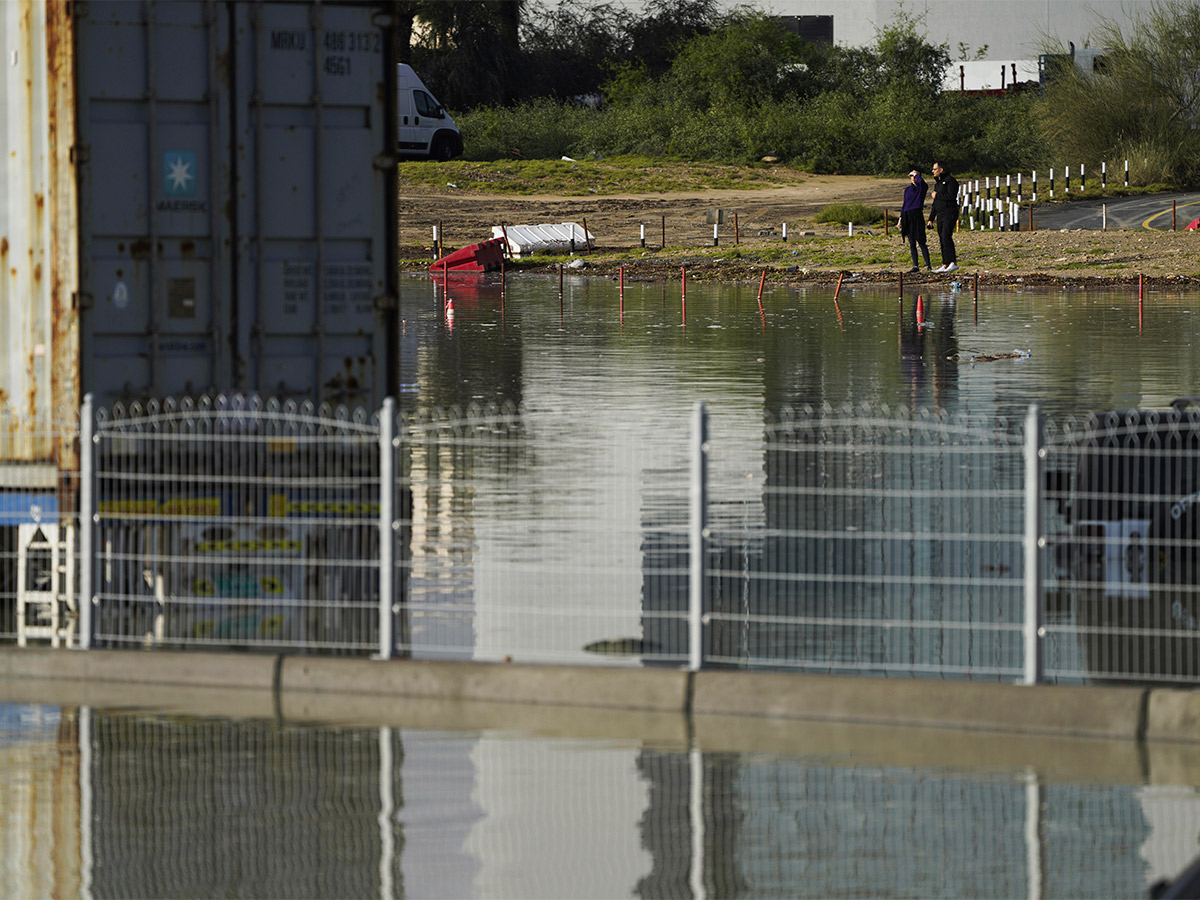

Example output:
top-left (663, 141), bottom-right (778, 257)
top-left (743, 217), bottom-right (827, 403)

top-left (0, 647), bottom-right (1200, 743)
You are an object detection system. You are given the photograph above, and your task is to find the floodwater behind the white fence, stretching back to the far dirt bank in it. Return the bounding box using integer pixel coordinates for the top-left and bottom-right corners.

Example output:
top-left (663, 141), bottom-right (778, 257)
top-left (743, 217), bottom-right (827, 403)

top-left (401, 275), bottom-right (1200, 680)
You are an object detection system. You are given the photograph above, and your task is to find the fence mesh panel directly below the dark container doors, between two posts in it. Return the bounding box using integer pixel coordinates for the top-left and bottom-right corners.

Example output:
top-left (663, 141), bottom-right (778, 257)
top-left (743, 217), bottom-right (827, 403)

top-left (95, 397), bottom-right (379, 650)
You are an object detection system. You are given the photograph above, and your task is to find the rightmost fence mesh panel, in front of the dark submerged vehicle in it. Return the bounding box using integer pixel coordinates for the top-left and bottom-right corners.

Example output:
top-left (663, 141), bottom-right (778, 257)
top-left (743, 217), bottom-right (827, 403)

top-left (1045, 403), bottom-right (1200, 682)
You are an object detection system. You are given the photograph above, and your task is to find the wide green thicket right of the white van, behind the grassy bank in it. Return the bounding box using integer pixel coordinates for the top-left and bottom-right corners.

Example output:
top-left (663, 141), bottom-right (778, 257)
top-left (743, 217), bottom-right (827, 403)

top-left (448, 7), bottom-right (1041, 175)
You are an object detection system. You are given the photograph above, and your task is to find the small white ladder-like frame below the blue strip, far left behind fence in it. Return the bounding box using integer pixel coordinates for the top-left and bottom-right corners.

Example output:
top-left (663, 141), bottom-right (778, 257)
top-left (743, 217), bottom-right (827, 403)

top-left (17, 522), bottom-right (78, 647)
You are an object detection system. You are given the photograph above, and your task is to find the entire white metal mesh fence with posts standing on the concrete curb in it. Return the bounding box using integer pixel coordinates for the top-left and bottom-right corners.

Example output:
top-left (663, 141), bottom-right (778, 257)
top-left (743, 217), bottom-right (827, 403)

top-left (0, 396), bottom-right (1200, 683)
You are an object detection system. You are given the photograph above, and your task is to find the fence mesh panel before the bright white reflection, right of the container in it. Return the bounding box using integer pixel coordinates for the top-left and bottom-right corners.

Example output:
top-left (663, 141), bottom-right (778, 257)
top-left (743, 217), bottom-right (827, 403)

top-left (400, 408), bottom-right (688, 665)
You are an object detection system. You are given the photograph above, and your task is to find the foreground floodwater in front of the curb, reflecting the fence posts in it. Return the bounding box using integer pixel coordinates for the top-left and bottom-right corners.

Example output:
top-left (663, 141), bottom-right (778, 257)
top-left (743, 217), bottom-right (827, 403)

top-left (7, 703), bottom-right (1200, 899)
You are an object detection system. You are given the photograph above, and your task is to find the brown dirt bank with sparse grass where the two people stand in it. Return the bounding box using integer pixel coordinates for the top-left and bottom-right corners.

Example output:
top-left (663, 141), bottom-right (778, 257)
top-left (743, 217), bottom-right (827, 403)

top-left (400, 175), bottom-right (1200, 284)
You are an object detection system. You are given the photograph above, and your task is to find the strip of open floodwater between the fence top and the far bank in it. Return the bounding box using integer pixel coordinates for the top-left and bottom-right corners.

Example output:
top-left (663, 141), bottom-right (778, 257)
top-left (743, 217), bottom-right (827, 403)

top-left (401, 275), bottom-right (1200, 424)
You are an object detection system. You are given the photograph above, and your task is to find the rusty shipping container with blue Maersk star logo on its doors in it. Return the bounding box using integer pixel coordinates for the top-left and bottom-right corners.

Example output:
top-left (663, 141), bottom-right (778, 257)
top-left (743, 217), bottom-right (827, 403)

top-left (0, 0), bottom-right (398, 470)
